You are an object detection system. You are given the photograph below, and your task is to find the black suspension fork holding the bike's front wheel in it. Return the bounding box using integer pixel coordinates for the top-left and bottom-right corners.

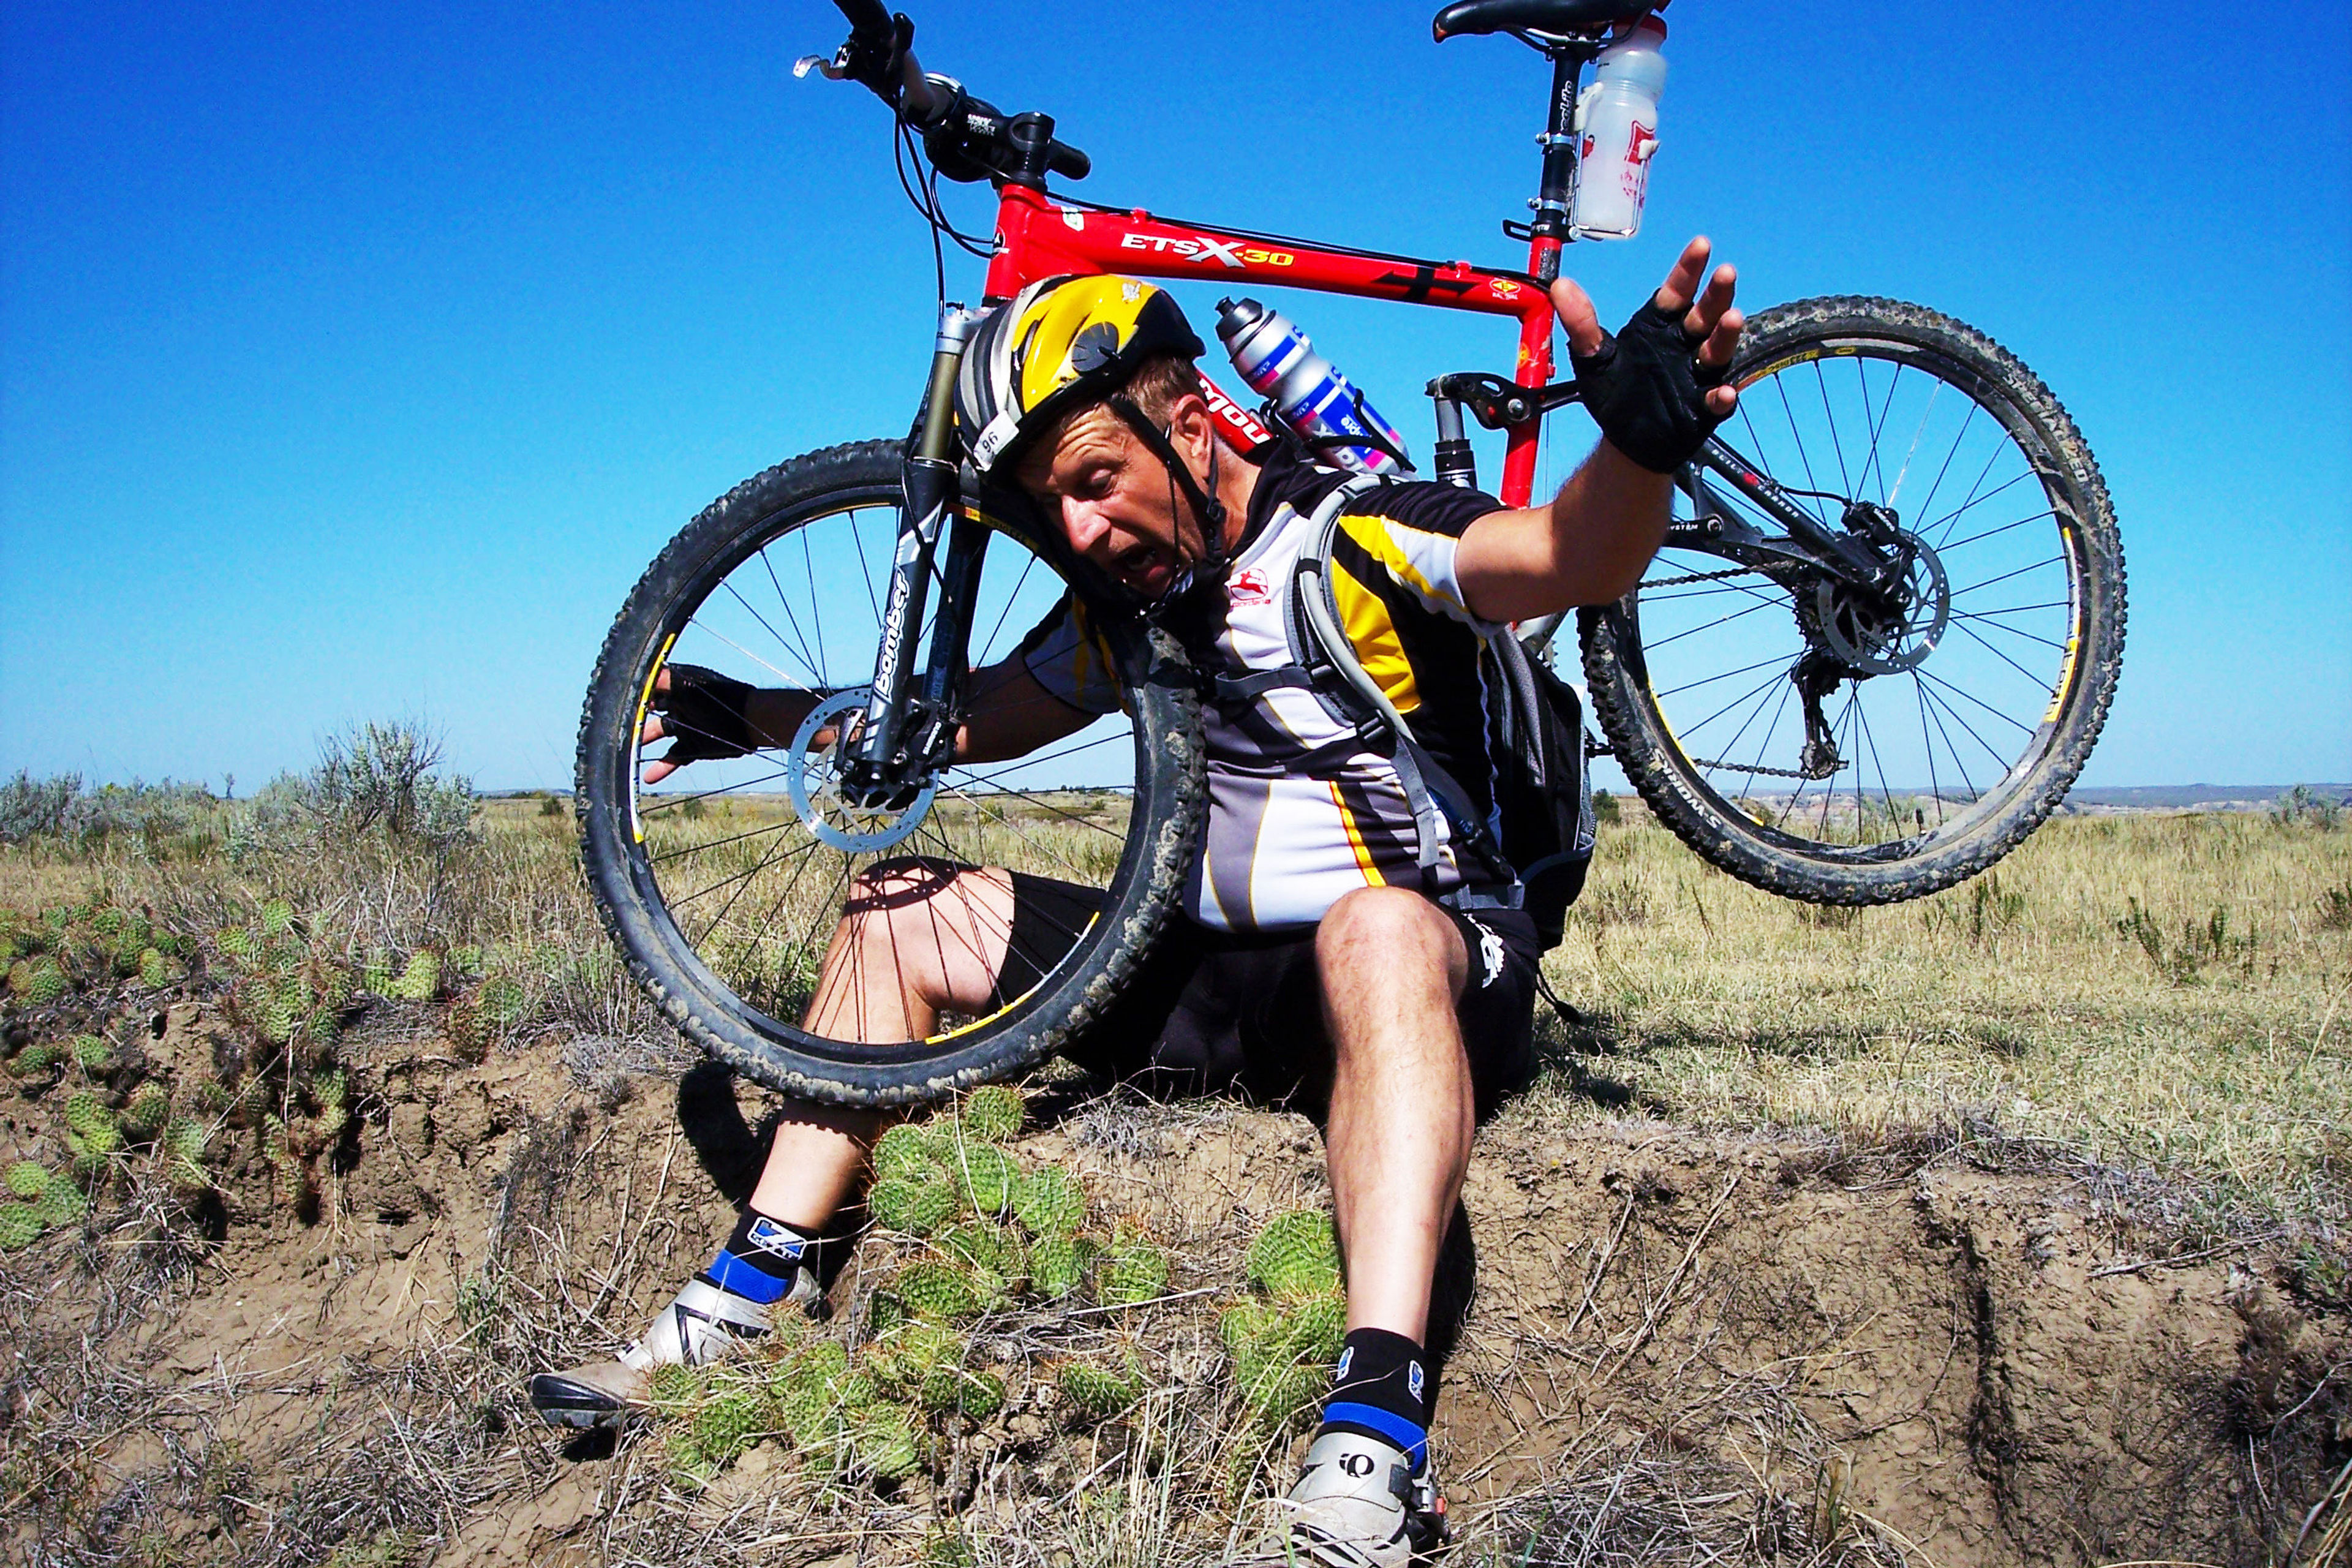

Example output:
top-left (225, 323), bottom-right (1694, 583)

top-left (842, 306), bottom-right (988, 804)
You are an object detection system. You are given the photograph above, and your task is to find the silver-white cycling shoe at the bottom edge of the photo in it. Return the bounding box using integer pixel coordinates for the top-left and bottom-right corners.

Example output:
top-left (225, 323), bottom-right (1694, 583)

top-left (1230, 1431), bottom-right (1447, 1568)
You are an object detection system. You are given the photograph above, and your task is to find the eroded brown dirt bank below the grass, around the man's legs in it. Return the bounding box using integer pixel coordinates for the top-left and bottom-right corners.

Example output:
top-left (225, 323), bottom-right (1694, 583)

top-left (0, 1001), bottom-right (2352, 1568)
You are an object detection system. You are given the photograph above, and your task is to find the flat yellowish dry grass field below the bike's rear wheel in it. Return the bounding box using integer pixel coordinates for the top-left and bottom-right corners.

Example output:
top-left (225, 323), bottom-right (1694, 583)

top-left (1545, 811), bottom-right (2352, 1215)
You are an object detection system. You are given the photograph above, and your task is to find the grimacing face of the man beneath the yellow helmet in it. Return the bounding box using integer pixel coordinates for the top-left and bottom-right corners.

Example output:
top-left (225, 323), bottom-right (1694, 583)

top-left (1021, 407), bottom-right (1207, 600)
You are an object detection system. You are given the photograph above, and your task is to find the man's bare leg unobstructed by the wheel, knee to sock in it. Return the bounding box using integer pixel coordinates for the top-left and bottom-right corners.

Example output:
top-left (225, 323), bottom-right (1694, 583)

top-left (1315, 889), bottom-right (1477, 1344)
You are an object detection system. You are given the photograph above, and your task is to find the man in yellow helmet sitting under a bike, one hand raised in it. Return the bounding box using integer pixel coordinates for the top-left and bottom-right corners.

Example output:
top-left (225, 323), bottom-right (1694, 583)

top-left (532, 239), bottom-right (1741, 1568)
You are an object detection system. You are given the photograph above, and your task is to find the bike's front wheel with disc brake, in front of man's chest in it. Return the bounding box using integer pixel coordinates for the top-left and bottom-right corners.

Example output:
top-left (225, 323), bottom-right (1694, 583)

top-left (576, 442), bottom-right (1202, 1105)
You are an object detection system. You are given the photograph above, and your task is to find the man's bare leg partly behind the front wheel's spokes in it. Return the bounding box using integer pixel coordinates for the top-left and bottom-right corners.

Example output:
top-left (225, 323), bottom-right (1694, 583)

top-left (750, 861), bottom-right (1014, 1232)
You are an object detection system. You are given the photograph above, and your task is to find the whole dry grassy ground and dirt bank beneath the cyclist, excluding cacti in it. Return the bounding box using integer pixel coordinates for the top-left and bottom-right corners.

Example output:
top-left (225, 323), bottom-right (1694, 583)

top-left (0, 766), bottom-right (2352, 1568)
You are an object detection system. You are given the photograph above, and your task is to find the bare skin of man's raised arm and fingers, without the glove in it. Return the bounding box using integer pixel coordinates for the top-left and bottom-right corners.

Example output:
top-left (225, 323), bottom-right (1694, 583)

top-left (1453, 239), bottom-right (1741, 620)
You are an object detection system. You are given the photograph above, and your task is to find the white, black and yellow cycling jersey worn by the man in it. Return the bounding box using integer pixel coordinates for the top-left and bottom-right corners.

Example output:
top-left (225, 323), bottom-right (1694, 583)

top-left (1021, 449), bottom-right (1501, 931)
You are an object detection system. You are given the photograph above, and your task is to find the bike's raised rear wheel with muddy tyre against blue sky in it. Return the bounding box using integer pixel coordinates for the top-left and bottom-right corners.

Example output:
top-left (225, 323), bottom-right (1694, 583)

top-left (1580, 298), bottom-right (2124, 905)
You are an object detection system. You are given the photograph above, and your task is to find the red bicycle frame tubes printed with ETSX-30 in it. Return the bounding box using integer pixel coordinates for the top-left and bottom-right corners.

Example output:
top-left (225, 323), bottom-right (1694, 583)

top-left (988, 183), bottom-right (1559, 505)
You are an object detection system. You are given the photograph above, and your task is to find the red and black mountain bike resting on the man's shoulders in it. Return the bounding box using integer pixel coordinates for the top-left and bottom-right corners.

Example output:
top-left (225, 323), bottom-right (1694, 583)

top-left (576, 0), bottom-right (2124, 1105)
